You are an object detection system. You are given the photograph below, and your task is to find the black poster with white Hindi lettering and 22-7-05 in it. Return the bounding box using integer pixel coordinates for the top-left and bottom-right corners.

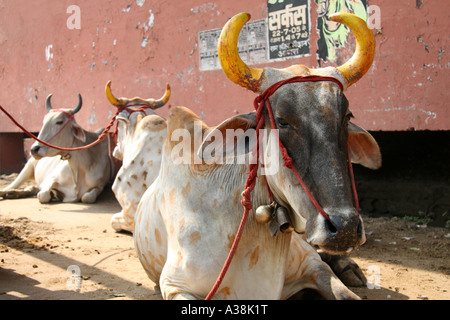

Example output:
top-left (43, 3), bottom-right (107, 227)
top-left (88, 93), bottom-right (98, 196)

top-left (267, 0), bottom-right (311, 60)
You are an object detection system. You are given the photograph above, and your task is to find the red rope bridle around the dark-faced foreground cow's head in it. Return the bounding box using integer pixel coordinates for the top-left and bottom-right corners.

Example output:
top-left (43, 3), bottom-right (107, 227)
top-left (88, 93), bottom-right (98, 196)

top-left (206, 76), bottom-right (359, 300)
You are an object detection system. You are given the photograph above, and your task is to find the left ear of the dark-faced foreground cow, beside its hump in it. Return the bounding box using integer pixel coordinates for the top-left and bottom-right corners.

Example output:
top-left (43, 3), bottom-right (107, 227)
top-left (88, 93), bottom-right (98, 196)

top-left (198, 112), bottom-right (256, 163)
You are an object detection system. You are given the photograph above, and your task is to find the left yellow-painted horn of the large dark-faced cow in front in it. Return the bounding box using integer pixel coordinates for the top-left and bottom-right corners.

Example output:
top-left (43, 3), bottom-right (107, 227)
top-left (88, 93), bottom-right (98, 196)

top-left (217, 12), bottom-right (263, 92)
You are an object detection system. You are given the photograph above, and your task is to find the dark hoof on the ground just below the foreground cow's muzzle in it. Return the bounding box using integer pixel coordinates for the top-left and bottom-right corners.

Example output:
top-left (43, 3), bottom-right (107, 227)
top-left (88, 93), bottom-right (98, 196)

top-left (320, 252), bottom-right (367, 287)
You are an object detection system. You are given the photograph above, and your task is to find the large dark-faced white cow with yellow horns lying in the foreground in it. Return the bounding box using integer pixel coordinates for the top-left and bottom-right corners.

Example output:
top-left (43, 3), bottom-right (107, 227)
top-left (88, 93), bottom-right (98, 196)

top-left (134, 13), bottom-right (381, 299)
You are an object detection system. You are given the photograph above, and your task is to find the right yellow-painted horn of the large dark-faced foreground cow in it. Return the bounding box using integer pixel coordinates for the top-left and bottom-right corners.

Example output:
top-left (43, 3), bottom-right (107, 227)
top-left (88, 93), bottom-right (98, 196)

top-left (328, 12), bottom-right (375, 86)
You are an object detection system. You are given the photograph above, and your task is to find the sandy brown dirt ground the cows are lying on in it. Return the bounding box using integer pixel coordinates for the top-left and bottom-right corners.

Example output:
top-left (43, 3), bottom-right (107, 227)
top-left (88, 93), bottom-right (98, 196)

top-left (0, 175), bottom-right (450, 300)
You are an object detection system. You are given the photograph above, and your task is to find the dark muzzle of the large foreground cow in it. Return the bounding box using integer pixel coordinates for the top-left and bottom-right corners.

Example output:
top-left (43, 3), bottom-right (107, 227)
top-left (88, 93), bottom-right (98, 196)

top-left (306, 212), bottom-right (366, 254)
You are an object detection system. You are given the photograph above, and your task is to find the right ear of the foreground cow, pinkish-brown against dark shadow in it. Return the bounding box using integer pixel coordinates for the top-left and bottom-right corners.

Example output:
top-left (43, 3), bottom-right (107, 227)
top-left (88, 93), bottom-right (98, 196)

top-left (348, 122), bottom-right (381, 170)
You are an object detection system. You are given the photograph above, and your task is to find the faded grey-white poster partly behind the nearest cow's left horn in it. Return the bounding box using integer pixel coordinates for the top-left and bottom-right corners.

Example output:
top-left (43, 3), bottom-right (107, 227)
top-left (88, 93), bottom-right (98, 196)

top-left (199, 20), bottom-right (267, 71)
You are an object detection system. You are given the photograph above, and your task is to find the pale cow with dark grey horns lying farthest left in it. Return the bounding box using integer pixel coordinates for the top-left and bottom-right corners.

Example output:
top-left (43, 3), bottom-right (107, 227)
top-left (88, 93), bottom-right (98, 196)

top-left (3, 95), bottom-right (113, 203)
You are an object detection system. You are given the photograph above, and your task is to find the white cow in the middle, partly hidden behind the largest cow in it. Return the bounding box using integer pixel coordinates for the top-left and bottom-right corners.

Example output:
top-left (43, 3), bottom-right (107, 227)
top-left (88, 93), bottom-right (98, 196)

top-left (105, 81), bottom-right (171, 232)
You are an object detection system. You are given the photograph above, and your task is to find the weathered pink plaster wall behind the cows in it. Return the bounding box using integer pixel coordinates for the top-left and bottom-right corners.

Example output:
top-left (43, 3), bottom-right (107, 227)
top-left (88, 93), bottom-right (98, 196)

top-left (0, 0), bottom-right (450, 133)
